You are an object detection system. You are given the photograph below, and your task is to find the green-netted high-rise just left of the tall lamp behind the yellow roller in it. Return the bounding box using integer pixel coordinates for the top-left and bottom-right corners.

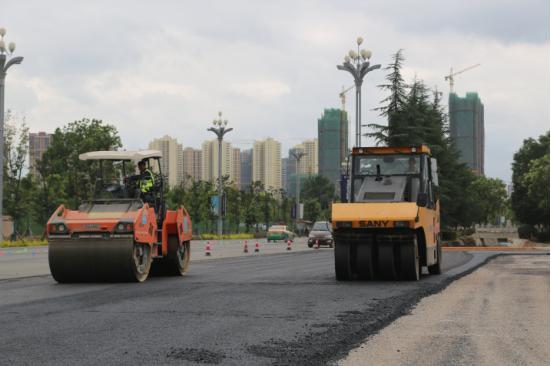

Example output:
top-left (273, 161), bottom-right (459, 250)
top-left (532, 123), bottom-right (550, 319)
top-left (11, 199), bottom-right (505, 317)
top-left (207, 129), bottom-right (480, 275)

top-left (318, 108), bottom-right (348, 187)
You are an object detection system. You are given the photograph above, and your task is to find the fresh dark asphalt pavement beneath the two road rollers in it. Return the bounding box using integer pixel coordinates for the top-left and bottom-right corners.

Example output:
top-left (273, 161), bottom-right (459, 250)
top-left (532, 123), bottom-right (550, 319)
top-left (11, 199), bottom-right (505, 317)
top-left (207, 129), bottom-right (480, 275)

top-left (0, 244), bottom-right (508, 365)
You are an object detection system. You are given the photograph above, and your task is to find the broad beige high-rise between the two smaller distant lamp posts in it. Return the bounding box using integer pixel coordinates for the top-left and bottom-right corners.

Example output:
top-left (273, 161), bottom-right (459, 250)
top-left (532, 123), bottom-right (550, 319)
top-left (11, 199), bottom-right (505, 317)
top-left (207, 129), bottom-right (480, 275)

top-left (252, 137), bottom-right (282, 189)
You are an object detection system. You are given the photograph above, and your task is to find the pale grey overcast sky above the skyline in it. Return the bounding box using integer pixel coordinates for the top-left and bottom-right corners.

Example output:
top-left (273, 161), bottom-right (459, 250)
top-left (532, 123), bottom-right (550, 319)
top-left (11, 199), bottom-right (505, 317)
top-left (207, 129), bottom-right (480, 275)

top-left (0, 0), bottom-right (549, 181)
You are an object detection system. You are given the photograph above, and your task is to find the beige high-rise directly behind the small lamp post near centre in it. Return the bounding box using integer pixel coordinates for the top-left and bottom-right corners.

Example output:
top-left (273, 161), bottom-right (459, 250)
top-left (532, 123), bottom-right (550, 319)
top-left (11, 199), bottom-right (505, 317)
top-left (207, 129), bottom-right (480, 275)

top-left (201, 139), bottom-right (239, 187)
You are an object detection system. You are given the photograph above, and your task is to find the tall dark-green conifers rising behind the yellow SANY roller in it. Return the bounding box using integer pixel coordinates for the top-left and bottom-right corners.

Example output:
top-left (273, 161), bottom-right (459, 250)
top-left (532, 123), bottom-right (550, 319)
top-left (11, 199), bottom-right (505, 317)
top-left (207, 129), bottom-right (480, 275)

top-left (367, 50), bottom-right (475, 227)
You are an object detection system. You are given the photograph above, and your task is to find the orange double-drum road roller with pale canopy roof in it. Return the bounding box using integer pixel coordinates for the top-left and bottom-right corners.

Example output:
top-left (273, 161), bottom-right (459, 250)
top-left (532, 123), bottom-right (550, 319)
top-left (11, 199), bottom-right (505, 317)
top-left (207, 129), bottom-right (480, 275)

top-left (46, 150), bottom-right (192, 282)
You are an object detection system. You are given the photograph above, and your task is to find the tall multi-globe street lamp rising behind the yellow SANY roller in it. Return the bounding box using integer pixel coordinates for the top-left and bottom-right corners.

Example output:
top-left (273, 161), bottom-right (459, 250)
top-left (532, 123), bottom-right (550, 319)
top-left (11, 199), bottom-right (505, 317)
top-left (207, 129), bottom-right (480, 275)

top-left (337, 37), bottom-right (381, 146)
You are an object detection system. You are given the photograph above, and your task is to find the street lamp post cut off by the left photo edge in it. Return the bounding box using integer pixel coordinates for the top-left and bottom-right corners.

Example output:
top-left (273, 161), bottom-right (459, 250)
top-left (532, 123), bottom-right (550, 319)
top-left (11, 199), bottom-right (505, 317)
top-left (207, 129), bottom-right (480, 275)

top-left (0, 28), bottom-right (23, 239)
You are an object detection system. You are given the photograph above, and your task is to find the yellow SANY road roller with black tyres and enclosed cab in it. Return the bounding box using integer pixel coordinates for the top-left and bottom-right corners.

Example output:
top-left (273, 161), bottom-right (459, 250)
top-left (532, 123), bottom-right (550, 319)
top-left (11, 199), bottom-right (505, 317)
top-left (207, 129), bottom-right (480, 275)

top-left (332, 145), bottom-right (442, 281)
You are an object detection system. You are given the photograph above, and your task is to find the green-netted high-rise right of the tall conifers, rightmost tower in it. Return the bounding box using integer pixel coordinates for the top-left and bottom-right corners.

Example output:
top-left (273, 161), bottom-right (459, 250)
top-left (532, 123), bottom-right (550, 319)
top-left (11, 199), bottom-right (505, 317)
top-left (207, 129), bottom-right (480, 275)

top-left (448, 93), bottom-right (484, 175)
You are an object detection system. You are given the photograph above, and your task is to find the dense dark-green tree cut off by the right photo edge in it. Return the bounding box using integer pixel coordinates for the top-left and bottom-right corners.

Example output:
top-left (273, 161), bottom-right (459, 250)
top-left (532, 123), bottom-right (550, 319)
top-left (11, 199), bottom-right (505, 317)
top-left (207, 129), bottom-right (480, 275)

top-left (511, 131), bottom-right (549, 240)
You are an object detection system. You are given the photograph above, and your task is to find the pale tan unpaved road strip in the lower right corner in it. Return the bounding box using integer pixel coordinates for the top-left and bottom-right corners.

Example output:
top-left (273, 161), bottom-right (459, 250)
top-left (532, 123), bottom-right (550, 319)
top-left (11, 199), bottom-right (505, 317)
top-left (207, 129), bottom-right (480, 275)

top-left (339, 256), bottom-right (549, 366)
